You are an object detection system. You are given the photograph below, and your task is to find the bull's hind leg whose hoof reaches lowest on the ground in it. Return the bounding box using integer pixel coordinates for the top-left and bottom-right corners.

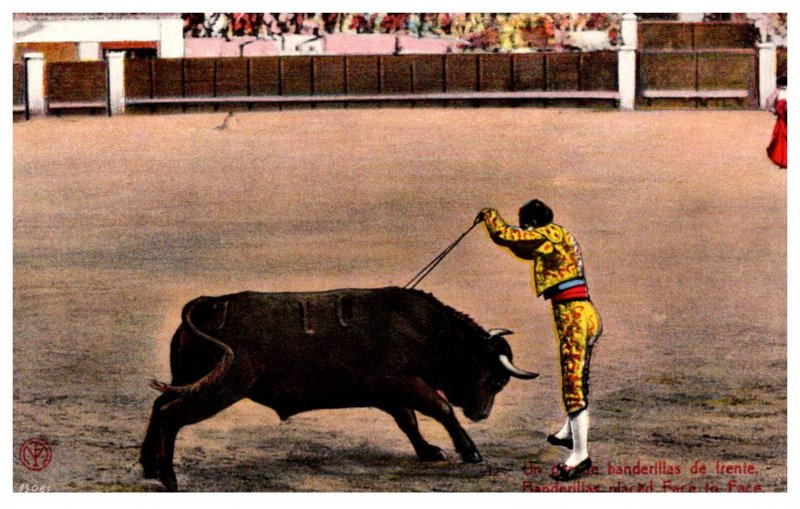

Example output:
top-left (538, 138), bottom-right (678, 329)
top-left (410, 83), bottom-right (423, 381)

top-left (156, 390), bottom-right (244, 491)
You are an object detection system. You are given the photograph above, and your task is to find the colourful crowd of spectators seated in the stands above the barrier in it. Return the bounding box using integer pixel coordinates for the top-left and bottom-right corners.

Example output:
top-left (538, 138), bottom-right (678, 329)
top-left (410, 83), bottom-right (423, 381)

top-left (183, 13), bottom-right (620, 51)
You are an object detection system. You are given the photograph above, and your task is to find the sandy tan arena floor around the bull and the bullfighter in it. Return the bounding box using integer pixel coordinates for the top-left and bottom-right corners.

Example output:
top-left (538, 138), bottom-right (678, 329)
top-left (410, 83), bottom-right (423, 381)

top-left (13, 108), bottom-right (787, 492)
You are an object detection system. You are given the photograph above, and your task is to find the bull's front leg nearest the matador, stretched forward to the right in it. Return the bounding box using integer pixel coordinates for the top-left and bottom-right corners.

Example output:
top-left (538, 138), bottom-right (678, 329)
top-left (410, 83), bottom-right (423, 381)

top-left (379, 377), bottom-right (483, 463)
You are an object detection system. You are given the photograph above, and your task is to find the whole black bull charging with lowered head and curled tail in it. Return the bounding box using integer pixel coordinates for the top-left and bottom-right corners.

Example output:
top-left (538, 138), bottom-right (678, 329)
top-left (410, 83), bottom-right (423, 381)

top-left (140, 287), bottom-right (537, 490)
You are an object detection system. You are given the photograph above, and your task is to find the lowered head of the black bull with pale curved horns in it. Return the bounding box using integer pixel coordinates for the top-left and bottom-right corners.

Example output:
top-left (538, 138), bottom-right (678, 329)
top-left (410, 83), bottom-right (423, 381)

top-left (450, 329), bottom-right (539, 421)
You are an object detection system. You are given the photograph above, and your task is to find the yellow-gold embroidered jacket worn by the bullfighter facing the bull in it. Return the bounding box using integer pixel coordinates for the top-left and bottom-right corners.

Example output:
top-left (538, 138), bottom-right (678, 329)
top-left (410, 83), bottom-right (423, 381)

top-left (481, 208), bottom-right (584, 296)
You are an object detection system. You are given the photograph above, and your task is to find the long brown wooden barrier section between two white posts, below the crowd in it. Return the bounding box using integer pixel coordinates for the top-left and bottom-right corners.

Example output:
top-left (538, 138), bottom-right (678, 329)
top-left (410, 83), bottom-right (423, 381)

top-left (117, 51), bottom-right (618, 109)
